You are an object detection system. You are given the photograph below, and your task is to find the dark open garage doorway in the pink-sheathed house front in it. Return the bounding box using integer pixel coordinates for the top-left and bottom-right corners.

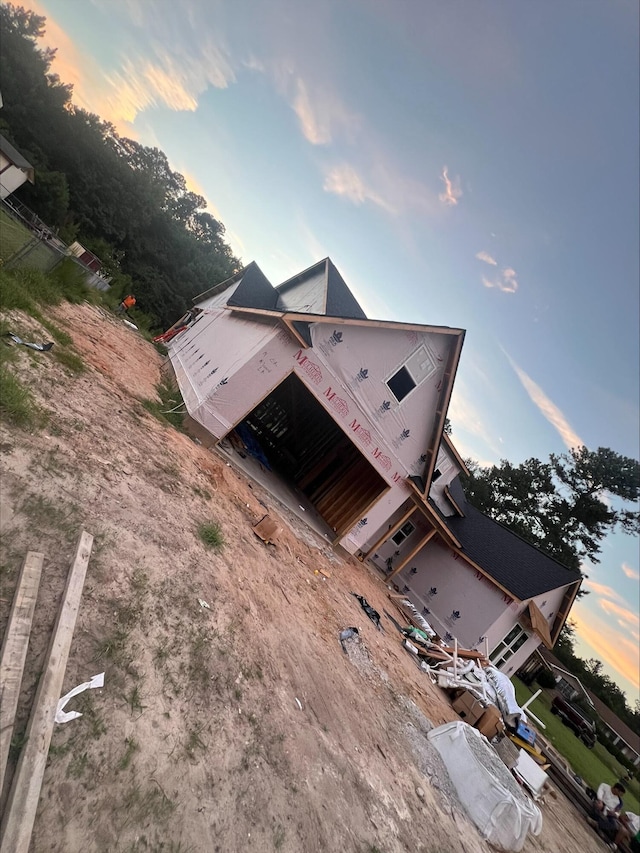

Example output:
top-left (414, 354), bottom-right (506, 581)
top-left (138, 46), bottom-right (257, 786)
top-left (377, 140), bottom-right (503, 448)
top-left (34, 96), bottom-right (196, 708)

top-left (234, 374), bottom-right (389, 538)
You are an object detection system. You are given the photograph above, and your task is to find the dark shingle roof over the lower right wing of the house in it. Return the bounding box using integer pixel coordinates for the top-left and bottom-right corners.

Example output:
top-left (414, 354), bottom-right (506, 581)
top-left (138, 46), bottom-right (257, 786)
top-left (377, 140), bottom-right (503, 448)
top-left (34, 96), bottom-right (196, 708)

top-left (440, 477), bottom-right (581, 601)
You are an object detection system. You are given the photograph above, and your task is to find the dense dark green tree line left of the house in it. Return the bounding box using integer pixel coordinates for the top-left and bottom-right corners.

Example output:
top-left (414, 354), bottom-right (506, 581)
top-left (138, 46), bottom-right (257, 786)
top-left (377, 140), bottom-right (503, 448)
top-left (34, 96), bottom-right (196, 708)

top-left (0, 3), bottom-right (240, 327)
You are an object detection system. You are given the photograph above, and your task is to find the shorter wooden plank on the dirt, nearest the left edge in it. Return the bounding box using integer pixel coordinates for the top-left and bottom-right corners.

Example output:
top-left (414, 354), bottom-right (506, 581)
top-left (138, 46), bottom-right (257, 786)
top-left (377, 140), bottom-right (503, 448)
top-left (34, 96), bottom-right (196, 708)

top-left (0, 551), bottom-right (44, 792)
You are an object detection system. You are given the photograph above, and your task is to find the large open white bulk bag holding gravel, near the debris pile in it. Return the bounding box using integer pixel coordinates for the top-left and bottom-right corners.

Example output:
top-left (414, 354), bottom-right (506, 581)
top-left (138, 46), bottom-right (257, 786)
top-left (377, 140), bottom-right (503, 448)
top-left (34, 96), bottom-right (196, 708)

top-left (428, 722), bottom-right (542, 853)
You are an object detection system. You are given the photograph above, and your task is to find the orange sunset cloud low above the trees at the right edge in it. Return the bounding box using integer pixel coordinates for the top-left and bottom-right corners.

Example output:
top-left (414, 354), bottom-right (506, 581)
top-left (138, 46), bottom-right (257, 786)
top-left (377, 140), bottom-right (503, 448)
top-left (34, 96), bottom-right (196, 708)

top-left (571, 602), bottom-right (640, 704)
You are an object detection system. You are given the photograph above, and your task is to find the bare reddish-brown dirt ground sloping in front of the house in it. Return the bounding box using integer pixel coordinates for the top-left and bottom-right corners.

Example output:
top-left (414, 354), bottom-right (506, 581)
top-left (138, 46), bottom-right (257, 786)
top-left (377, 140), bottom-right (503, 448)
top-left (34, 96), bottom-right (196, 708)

top-left (0, 305), bottom-right (605, 853)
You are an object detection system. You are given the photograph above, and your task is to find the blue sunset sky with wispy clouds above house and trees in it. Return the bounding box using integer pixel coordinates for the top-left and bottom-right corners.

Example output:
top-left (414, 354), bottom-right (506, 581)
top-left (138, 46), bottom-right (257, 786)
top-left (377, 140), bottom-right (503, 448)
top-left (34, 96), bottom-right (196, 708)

top-left (30, 0), bottom-right (640, 704)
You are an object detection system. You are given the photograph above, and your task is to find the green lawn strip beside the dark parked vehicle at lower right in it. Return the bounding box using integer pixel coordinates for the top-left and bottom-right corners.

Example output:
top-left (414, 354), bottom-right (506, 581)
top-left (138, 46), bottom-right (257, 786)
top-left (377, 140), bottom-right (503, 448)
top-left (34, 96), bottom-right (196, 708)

top-left (511, 678), bottom-right (640, 814)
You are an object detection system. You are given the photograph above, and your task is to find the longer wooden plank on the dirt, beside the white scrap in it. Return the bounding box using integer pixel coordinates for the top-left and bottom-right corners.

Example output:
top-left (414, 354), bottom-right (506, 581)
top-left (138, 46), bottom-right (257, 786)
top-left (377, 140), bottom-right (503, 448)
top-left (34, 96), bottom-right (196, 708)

top-left (0, 530), bottom-right (93, 853)
